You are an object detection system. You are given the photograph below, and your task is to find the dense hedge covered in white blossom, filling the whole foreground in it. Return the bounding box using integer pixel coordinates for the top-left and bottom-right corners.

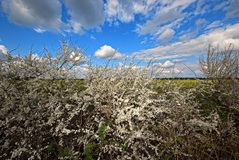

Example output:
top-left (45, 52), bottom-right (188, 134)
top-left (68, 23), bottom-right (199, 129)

top-left (0, 42), bottom-right (239, 160)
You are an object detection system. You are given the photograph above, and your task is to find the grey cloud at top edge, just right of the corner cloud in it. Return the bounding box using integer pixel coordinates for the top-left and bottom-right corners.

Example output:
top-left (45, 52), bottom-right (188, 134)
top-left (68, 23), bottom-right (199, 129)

top-left (65, 0), bottom-right (104, 34)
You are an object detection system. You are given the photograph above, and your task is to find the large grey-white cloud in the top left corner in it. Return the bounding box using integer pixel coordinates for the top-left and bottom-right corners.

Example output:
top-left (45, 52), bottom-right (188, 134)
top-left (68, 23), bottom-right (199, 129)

top-left (2, 0), bottom-right (65, 31)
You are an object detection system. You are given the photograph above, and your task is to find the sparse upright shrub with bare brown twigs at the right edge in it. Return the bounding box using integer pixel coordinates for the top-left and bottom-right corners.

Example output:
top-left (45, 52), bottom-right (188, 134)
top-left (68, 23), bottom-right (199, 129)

top-left (199, 44), bottom-right (239, 111)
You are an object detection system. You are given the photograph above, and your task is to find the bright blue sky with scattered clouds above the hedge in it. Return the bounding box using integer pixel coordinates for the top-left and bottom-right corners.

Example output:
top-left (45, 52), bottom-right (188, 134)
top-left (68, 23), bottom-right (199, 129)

top-left (0, 0), bottom-right (239, 77)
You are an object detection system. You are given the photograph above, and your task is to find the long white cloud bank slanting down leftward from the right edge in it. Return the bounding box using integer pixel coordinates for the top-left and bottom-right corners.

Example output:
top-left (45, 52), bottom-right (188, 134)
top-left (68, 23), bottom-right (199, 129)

top-left (134, 23), bottom-right (239, 60)
